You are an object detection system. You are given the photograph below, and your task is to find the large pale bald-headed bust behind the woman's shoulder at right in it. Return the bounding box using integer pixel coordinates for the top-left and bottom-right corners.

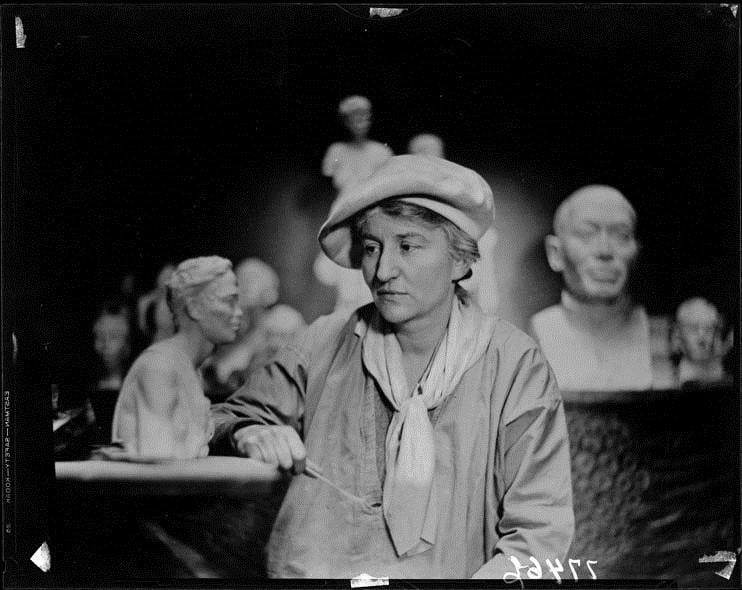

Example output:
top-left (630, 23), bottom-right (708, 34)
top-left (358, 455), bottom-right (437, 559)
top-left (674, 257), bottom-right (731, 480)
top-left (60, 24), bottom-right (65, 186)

top-left (530, 184), bottom-right (652, 390)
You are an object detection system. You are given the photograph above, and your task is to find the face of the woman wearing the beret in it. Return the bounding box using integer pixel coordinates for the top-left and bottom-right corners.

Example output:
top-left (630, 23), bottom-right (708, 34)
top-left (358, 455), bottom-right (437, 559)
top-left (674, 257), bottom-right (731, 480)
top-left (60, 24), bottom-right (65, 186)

top-left (360, 209), bottom-right (466, 329)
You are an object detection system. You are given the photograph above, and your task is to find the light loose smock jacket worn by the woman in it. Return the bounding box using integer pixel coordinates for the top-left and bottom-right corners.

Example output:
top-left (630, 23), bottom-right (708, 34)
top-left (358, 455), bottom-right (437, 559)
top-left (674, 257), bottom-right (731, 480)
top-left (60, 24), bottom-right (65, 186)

top-left (211, 304), bottom-right (574, 579)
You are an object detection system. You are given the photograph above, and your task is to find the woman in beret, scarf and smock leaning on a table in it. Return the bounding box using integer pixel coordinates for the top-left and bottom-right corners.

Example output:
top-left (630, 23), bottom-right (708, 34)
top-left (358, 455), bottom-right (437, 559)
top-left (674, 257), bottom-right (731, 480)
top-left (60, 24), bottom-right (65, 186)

top-left (212, 155), bottom-right (573, 578)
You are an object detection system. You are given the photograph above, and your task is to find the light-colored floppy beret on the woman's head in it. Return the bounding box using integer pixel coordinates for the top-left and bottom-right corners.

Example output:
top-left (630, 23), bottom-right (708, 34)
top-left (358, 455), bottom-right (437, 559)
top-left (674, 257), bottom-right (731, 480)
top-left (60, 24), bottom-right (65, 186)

top-left (319, 155), bottom-right (495, 268)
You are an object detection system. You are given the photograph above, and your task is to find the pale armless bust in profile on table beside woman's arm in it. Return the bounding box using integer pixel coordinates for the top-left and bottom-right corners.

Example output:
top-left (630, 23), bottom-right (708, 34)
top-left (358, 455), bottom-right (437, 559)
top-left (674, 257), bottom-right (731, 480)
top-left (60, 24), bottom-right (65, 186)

top-left (112, 256), bottom-right (242, 459)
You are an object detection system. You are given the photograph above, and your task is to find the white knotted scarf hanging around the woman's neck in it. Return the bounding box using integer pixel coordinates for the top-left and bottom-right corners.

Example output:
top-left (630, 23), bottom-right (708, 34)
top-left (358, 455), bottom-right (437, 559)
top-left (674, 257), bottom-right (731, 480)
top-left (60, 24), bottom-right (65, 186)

top-left (363, 297), bottom-right (495, 557)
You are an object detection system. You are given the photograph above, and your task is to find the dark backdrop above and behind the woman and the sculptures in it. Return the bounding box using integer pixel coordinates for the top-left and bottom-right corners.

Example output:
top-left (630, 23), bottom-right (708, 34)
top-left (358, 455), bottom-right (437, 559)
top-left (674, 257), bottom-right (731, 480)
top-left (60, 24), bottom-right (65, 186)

top-left (2, 4), bottom-right (740, 588)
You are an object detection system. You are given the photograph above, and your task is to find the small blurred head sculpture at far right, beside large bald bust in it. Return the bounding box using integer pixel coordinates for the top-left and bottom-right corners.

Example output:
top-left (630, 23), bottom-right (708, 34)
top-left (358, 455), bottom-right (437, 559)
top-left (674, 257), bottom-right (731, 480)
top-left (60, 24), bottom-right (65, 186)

top-left (674, 297), bottom-right (733, 387)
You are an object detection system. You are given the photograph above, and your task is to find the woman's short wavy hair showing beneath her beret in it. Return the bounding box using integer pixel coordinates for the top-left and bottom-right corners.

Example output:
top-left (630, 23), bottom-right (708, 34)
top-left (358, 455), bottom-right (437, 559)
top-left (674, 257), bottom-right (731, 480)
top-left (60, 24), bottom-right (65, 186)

top-left (353, 195), bottom-right (480, 264)
